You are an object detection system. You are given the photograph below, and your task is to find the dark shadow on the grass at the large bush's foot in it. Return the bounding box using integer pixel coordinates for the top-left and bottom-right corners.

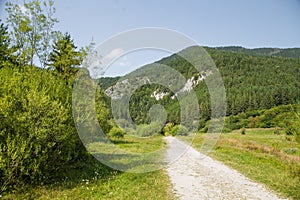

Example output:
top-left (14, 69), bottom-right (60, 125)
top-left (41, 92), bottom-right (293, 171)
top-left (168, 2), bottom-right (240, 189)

top-left (2, 155), bottom-right (122, 199)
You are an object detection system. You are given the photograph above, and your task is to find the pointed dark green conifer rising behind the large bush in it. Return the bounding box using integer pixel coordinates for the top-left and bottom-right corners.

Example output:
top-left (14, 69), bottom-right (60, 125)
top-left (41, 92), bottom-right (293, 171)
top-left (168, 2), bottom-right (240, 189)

top-left (48, 33), bottom-right (83, 77)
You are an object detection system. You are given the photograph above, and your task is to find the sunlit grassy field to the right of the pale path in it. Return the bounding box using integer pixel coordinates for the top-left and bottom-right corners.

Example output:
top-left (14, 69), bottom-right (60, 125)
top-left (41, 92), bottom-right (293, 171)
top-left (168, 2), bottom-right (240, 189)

top-left (182, 129), bottom-right (300, 199)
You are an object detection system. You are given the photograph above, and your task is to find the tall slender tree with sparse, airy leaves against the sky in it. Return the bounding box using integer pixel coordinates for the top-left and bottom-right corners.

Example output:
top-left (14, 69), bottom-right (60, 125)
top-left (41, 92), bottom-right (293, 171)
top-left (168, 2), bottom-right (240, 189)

top-left (6, 0), bottom-right (58, 67)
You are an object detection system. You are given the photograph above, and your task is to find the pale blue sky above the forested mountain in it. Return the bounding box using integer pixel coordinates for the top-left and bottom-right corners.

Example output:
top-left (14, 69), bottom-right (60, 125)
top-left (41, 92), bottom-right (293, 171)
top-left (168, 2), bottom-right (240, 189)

top-left (0, 0), bottom-right (300, 76)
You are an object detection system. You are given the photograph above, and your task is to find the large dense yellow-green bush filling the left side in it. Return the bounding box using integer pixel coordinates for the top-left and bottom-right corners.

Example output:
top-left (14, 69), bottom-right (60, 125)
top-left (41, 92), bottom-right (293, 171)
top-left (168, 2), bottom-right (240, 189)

top-left (0, 67), bottom-right (87, 191)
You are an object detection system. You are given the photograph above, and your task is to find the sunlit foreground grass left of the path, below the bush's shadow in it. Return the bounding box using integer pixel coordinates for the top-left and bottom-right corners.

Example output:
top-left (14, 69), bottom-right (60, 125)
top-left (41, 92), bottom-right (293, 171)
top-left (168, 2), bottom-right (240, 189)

top-left (3, 171), bottom-right (174, 199)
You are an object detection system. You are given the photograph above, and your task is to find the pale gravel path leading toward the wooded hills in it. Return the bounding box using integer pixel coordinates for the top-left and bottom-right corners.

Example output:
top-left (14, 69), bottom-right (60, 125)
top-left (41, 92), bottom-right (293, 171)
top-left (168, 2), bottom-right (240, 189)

top-left (165, 137), bottom-right (286, 200)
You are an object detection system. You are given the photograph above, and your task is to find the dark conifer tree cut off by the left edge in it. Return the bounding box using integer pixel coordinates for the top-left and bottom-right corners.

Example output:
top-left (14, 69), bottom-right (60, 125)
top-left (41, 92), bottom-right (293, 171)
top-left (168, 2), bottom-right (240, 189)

top-left (0, 20), bottom-right (14, 68)
